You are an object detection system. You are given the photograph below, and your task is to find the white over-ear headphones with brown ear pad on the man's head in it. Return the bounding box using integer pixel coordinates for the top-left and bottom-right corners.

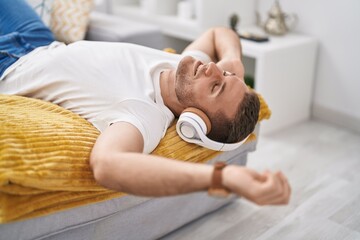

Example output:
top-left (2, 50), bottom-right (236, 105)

top-left (176, 108), bottom-right (249, 151)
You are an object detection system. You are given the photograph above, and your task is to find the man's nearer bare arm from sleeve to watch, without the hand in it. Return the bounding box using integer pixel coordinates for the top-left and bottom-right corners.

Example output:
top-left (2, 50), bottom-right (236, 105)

top-left (90, 122), bottom-right (212, 196)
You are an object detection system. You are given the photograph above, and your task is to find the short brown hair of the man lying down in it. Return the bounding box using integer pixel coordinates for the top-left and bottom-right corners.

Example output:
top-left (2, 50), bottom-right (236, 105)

top-left (208, 91), bottom-right (260, 143)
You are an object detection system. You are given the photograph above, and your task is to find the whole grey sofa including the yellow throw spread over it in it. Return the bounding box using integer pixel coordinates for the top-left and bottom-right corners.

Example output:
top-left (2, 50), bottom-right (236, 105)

top-left (0, 3), bottom-right (270, 240)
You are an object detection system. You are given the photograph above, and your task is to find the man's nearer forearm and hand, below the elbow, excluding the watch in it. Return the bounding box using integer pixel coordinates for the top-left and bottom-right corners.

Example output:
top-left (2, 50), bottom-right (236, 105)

top-left (92, 153), bottom-right (291, 205)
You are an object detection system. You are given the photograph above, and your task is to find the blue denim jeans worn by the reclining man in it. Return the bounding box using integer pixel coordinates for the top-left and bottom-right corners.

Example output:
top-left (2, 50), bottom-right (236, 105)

top-left (0, 0), bottom-right (55, 77)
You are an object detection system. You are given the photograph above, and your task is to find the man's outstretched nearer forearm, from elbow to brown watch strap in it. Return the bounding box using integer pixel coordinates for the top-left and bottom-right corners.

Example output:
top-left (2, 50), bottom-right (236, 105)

top-left (93, 153), bottom-right (213, 196)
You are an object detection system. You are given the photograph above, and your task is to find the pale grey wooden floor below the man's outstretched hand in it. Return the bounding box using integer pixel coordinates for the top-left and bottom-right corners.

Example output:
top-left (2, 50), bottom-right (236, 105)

top-left (163, 121), bottom-right (360, 240)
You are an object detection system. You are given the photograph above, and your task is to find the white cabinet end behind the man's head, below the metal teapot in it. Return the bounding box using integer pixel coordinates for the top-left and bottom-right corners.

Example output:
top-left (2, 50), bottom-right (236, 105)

top-left (241, 34), bottom-right (317, 134)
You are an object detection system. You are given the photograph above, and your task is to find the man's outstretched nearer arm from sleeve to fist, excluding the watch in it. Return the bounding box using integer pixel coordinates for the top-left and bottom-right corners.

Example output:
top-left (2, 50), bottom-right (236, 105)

top-left (90, 122), bottom-right (290, 205)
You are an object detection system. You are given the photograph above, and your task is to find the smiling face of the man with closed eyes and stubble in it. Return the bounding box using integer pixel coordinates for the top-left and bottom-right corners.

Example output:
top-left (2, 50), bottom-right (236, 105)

top-left (175, 56), bottom-right (248, 118)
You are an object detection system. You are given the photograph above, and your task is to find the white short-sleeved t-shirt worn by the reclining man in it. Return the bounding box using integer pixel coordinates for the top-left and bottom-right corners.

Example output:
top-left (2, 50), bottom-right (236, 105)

top-left (0, 41), bottom-right (210, 153)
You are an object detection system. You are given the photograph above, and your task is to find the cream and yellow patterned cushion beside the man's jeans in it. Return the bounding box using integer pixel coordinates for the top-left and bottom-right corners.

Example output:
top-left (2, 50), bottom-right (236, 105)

top-left (50, 0), bottom-right (93, 43)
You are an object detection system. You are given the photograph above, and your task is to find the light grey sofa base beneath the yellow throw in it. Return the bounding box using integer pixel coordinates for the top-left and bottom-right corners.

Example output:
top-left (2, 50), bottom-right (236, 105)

top-left (0, 141), bottom-right (256, 240)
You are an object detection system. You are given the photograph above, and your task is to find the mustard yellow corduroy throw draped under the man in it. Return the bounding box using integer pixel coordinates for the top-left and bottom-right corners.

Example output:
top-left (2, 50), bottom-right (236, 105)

top-left (0, 95), bottom-right (271, 223)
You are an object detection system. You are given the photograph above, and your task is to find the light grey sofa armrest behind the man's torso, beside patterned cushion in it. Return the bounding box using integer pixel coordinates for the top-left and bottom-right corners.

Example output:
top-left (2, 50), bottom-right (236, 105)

top-left (86, 12), bottom-right (164, 49)
